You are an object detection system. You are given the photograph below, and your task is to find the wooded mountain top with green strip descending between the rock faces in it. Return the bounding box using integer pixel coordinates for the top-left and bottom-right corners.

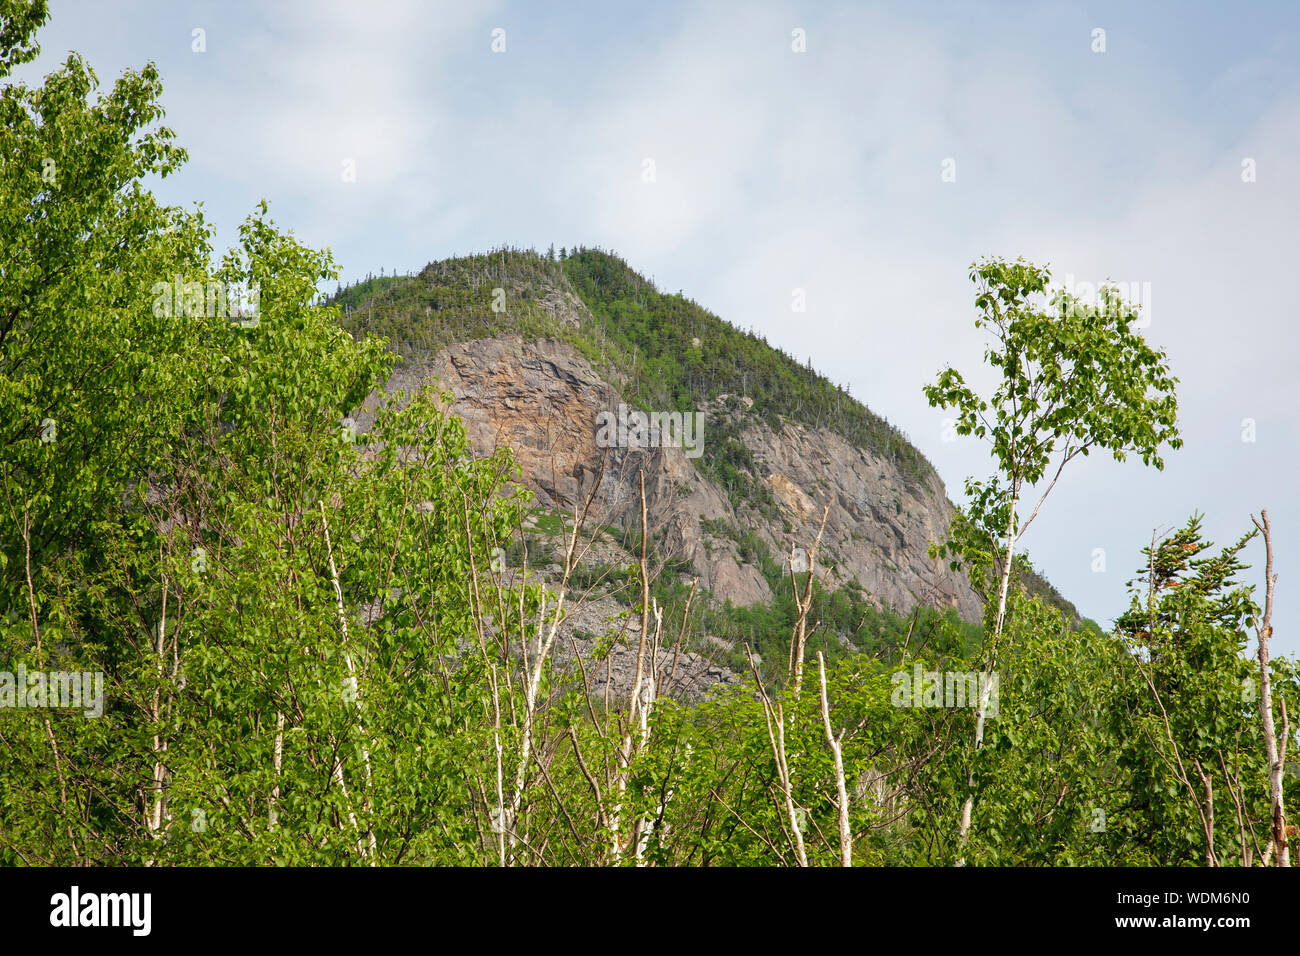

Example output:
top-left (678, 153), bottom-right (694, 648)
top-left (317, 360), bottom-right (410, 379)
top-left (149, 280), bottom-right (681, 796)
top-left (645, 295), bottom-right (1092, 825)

top-left (333, 248), bottom-right (1079, 620)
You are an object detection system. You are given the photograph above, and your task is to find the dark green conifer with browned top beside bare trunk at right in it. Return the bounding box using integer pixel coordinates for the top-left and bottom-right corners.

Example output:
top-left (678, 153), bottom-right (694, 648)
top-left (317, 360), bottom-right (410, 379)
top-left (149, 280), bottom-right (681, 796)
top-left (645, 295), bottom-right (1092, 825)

top-left (1113, 515), bottom-right (1297, 866)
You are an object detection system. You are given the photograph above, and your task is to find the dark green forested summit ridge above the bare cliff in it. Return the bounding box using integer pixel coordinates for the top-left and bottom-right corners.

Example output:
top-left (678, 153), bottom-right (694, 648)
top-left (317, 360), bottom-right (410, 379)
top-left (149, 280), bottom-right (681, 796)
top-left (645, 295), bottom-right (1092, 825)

top-left (333, 247), bottom-right (935, 489)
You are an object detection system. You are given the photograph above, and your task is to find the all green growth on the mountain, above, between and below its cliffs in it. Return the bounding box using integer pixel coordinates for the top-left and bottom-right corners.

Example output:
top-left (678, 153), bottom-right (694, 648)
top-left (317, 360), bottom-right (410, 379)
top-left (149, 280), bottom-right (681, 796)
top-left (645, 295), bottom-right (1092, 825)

top-left (330, 247), bottom-right (1097, 683)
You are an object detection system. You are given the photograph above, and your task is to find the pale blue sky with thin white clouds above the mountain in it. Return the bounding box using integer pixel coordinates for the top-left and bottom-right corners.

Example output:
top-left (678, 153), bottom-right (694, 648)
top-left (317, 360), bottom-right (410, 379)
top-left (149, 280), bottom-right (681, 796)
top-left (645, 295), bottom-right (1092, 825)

top-left (16, 0), bottom-right (1300, 656)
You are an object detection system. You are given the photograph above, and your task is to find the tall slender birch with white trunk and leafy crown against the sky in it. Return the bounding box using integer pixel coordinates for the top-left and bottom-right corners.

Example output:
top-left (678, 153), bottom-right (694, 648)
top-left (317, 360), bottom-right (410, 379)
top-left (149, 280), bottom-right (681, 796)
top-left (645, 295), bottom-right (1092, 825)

top-left (924, 259), bottom-right (1182, 862)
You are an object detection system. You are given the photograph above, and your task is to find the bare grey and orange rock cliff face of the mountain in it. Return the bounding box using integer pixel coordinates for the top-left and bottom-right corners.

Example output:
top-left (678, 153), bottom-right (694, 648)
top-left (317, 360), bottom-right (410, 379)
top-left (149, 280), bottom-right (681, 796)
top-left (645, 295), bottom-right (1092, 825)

top-left (377, 332), bottom-right (980, 620)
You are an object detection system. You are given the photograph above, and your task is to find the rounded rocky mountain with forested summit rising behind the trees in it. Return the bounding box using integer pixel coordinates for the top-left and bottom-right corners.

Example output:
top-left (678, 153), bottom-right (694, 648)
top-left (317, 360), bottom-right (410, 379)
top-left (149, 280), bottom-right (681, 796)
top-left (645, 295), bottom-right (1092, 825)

top-left (334, 248), bottom-right (1078, 686)
